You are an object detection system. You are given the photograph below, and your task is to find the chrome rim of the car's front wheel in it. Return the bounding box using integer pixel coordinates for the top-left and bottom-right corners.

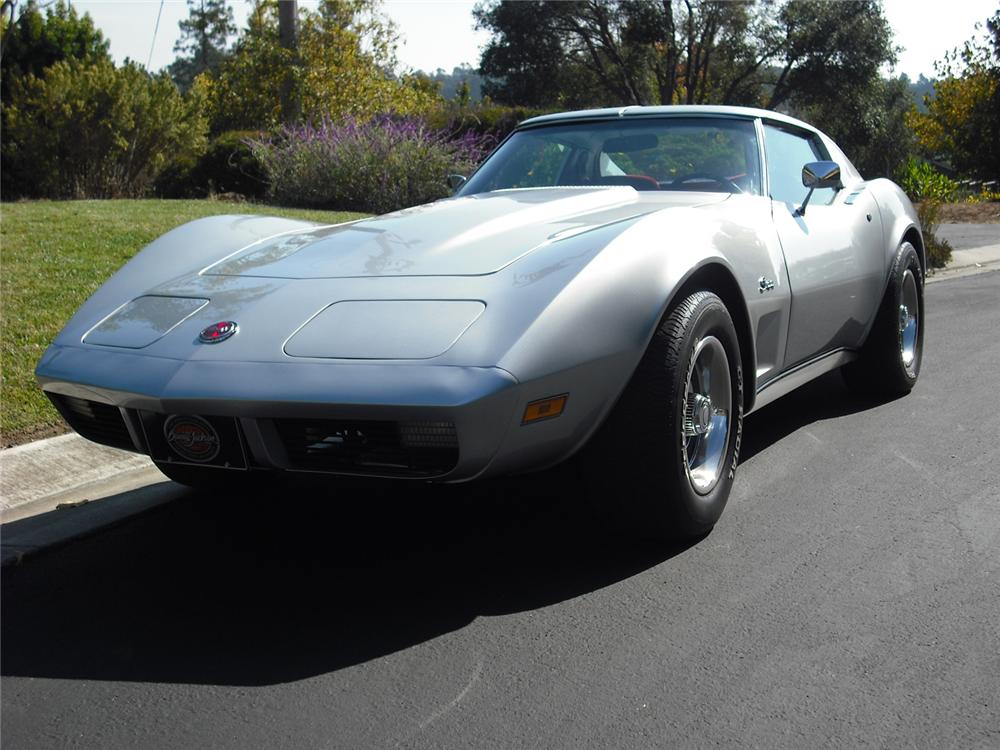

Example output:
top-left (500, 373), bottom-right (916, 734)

top-left (681, 336), bottom-right (733, 495)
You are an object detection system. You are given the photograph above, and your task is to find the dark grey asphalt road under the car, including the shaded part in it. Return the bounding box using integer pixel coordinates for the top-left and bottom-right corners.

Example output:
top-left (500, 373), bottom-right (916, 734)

top-left (0, 273), bottom-right (1000, 750)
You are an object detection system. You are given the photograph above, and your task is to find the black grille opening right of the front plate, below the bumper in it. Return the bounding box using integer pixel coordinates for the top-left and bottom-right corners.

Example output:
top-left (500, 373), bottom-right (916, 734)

top-left (275, 419), bottom-right (458, 476)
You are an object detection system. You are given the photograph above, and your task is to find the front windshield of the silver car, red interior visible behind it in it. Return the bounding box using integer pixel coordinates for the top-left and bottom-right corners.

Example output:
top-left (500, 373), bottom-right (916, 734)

top-left (459, 117), bottom-right (761, 195)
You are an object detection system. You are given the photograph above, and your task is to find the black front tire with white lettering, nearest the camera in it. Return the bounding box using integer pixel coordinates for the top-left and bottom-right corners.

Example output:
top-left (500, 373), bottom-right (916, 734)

top-left (582, 292), bottom-right (743, 541)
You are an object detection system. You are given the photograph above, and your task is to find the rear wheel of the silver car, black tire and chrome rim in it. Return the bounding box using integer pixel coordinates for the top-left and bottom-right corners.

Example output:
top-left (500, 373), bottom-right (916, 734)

top-left (842, 242), bottom-right (924, 398)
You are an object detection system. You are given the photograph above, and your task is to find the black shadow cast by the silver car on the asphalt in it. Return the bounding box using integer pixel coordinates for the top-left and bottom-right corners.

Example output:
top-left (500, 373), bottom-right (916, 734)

top-left (0, 368), bottom-right (892, 686)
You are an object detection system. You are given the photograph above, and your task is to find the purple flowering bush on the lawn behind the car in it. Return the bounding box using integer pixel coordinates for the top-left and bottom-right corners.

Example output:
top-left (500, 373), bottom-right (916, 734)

top-left (247, 116), bottom-right (493, 213)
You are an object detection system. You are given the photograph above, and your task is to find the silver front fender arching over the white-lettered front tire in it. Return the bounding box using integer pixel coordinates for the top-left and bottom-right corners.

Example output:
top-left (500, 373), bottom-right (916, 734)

top-left (484, 201), bottom-right (788, 472)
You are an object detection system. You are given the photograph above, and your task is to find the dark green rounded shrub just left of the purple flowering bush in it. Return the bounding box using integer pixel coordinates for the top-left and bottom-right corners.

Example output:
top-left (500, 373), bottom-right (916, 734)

top-left (156, 130), bottom-right (267, 200)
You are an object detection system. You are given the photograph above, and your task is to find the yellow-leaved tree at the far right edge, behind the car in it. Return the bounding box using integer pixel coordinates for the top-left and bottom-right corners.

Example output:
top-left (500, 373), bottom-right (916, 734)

top-left (910, 10), bottom-right (1000, 179)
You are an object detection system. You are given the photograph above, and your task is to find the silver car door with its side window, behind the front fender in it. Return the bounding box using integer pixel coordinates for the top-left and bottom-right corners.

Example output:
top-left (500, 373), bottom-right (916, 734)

top-left (763, 121), bottom-right (884, 367)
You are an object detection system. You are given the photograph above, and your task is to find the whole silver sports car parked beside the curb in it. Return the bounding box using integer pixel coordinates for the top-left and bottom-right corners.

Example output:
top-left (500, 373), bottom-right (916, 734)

top-left (37, 107), bottom-right (926, 538)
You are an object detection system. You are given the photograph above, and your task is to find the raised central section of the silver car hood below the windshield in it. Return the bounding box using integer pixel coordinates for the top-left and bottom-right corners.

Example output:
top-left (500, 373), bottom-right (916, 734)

top-left (202, 187), bottom-right (728, 279)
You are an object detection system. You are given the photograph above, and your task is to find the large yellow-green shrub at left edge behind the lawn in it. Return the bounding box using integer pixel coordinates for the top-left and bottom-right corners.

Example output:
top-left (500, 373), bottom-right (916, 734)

top-left (3, 60), bottom-right (207, 198)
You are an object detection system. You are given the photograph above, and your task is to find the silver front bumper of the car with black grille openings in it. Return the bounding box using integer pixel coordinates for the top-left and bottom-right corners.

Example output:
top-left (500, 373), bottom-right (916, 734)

top-left (36, 345), bottom-right (523, 481)
